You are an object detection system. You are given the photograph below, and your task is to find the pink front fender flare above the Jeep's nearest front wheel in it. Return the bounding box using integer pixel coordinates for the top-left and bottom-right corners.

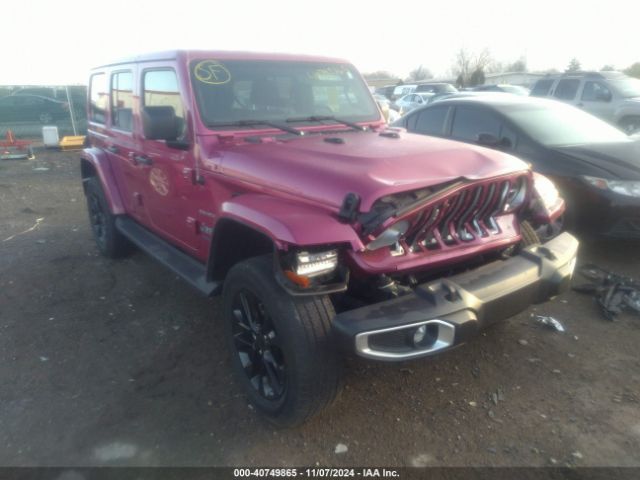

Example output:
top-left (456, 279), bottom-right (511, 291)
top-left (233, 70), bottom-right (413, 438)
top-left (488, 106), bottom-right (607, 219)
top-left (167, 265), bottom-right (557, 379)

top-left (220, 193), bottom-right (364, 250)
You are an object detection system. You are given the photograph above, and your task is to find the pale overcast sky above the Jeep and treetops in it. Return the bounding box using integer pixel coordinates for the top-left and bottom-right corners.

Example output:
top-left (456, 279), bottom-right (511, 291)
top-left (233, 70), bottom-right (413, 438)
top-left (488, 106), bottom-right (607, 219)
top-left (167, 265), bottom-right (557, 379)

top-left (0, 0), bottom-right (640, 85)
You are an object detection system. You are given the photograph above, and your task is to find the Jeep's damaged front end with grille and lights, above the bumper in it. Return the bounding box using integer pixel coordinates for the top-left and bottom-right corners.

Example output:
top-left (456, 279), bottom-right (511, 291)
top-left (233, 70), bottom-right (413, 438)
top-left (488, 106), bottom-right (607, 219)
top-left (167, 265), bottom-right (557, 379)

top-left (275, 171), bottom-right (564, 306)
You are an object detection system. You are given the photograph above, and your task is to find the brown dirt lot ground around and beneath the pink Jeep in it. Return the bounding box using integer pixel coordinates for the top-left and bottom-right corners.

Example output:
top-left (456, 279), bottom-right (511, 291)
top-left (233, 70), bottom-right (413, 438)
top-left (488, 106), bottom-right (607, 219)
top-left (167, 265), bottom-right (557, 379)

top-left (0, 149), bottom-right (640, 466)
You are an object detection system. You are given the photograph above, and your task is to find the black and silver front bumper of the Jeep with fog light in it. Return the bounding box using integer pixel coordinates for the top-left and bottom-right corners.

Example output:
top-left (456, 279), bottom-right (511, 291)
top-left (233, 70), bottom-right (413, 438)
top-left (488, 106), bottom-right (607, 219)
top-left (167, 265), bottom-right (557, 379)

top-left (333, 233), bottom-right (578, 361)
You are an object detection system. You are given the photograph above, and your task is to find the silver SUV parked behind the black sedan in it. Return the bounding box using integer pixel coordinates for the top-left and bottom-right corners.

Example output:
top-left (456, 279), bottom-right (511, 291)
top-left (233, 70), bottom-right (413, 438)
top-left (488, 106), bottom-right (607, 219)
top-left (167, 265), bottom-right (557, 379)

top-left (531, 72), bottom-right (640, 134)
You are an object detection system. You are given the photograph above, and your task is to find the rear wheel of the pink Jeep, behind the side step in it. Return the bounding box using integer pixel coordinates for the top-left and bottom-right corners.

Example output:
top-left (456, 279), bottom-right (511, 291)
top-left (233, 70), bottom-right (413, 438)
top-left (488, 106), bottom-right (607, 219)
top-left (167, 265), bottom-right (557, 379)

top-left (85, 177), bottom-right (132, 258)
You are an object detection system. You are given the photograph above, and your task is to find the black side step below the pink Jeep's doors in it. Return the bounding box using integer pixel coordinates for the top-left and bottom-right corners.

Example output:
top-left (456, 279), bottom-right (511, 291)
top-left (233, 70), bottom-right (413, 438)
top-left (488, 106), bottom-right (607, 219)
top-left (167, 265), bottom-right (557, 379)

top-left (116, 216), bottom-right (222, 296)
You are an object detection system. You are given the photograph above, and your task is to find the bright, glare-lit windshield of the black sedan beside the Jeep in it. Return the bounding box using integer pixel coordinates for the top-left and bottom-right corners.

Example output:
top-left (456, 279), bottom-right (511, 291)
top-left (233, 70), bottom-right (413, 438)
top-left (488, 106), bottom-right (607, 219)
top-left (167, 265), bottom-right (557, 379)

top-left (502, 102), bottom-right (630, 146)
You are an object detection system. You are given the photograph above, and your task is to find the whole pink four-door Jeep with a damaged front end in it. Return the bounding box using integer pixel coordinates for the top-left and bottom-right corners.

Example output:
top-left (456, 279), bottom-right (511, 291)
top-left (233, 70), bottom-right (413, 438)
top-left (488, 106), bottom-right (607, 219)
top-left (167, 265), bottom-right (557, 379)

top-left (81, 51), bottom-right (578, 425)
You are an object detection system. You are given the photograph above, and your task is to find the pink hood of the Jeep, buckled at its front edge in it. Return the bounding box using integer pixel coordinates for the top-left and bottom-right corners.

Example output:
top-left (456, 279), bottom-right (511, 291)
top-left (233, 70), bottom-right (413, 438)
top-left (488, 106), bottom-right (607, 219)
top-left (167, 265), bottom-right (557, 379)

top-left (215, 131), bottom-right (528, 212)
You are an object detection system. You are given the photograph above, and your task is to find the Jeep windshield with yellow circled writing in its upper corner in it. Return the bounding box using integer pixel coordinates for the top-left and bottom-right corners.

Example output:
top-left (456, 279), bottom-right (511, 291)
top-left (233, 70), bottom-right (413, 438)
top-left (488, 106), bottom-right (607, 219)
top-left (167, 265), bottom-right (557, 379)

top-left (191, 60), bottom-right (380, 127)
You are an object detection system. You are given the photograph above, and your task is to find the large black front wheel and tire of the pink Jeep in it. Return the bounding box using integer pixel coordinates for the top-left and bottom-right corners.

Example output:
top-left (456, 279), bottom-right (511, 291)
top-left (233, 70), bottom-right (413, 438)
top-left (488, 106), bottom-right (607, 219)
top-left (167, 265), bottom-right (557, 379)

top-left (223, 255), bottom-right (341, 427)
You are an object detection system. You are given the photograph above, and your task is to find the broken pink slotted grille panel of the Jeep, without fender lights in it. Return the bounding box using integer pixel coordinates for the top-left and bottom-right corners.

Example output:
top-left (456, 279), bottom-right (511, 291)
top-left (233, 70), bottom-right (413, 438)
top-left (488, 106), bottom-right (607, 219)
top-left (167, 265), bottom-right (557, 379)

top-left (351, 173), bottom-right (536, 274)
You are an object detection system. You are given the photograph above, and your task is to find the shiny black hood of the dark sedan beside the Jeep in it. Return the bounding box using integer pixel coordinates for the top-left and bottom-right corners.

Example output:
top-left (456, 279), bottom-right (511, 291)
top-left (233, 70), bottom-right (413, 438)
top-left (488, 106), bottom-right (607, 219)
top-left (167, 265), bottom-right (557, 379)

top-left (553, 142), bottom-right (640, 180)
